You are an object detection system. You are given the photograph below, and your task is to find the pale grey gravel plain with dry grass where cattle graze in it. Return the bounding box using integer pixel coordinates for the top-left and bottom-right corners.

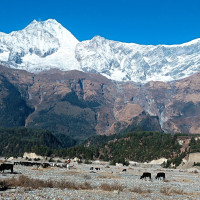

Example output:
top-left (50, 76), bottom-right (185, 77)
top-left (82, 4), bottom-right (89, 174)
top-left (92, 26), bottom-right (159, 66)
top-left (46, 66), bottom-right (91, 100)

top-left (0, 163), bottom-right (200, 200)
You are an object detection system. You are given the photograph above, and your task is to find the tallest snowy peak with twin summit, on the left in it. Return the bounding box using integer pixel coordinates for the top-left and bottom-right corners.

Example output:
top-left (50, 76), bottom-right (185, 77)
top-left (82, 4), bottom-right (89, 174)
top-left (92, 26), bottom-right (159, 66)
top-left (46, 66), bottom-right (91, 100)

top-left (0, 19), bottom-right (79, 72)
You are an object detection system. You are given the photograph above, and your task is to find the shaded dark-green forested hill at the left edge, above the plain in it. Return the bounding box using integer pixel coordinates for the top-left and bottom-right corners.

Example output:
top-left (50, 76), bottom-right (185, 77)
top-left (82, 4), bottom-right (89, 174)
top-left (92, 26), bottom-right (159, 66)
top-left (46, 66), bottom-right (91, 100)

top-left (0, 128), bottom-right (75, 156)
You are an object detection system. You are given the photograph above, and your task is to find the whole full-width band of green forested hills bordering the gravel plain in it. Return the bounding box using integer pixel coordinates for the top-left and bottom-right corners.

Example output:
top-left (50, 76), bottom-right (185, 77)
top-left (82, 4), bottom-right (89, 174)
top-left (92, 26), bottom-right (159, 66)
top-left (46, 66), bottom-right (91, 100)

top-left (0, 128), bottom-right (200, 167)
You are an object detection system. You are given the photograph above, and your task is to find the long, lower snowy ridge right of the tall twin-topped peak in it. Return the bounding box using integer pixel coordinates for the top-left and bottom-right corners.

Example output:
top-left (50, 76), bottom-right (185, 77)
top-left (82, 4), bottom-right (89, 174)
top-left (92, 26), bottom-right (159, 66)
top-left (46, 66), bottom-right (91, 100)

top-left (75, 36), bottom-right (200, 82)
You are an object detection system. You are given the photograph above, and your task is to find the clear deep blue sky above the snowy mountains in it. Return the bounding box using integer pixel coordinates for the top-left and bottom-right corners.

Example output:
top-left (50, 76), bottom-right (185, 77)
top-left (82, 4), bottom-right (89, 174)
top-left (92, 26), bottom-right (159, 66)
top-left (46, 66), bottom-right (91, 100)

top-left (0, 0), bottom-right (200, 44)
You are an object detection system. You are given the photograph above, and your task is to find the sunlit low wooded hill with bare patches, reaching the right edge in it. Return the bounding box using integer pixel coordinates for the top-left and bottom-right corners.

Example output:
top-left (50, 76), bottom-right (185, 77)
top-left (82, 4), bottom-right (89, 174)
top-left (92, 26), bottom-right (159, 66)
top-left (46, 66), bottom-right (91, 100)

top-left (59, 131), bottom-right (200, 167)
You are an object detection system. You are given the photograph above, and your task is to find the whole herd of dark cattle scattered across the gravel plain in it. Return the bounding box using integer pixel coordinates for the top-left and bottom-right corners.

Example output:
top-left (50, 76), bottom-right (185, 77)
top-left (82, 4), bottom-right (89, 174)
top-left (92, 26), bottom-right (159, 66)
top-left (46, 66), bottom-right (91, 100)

top-left (0, 162), bottom-right (165, 180)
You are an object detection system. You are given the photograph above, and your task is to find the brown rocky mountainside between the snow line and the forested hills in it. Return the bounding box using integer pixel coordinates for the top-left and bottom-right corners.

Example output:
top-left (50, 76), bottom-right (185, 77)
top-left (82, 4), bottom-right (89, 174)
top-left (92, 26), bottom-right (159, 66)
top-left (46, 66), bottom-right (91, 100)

top-left (0, 66), bottom-right (200, 139)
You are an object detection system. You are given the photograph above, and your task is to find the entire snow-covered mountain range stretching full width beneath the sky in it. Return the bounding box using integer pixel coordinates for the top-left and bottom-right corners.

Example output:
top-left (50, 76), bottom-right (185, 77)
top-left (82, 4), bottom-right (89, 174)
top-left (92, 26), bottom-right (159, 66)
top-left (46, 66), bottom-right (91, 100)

top-left (0, 19), bottom-right (200, 83)
